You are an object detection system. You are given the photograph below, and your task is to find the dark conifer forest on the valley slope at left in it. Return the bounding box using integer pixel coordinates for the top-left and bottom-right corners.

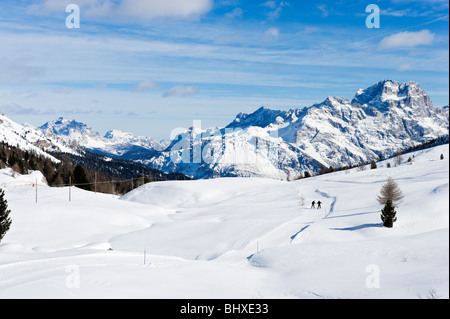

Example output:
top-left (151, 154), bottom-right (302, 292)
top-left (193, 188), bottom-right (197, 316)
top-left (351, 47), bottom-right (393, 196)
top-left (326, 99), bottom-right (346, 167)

top-left (0, 142), bottom-right (189, 195)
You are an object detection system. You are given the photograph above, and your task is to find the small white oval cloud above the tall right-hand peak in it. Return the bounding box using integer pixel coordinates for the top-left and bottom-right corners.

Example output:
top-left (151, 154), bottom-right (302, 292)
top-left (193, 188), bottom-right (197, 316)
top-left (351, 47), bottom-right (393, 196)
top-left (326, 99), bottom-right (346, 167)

top-left (378, 30), bottom-right (436, 50)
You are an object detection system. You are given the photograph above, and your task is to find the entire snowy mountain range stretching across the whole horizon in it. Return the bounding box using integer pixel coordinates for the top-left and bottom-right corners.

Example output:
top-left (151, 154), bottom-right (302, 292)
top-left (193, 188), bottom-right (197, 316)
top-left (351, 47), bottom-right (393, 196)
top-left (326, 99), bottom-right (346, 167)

top-left (0, 80), bottom-right (449, 180)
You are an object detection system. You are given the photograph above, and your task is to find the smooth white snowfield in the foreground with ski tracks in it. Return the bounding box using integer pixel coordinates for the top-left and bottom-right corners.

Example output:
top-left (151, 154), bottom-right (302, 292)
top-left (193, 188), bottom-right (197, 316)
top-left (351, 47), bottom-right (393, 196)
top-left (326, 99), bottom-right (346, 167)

top-left (0, 145), bottom-right (449, 299)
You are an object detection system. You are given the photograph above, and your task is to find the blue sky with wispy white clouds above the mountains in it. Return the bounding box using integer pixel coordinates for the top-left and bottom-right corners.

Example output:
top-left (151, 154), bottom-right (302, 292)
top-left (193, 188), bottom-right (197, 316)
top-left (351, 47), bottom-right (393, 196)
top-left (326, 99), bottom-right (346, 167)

top-left (0, 0), bottom-right (449, 139)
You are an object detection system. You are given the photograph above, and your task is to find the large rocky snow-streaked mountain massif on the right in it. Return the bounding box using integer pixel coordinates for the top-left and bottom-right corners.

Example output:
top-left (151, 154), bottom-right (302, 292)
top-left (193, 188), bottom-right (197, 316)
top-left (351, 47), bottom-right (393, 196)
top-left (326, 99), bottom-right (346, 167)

top-left (144, 81), bottom-right (449, 179)
